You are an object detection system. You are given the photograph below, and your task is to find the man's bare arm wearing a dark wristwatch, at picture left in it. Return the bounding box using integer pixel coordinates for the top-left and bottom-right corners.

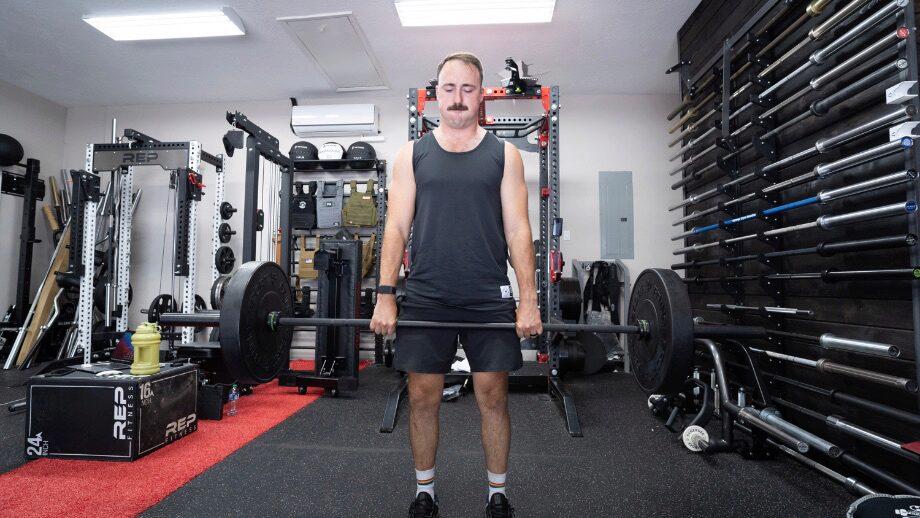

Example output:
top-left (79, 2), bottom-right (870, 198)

top-left (371, 142), bottom-right (415, 335)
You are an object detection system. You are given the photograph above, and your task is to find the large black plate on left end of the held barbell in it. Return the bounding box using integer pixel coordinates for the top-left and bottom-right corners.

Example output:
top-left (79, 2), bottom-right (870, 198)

top-left (220, 261), bottom-right (294, 384)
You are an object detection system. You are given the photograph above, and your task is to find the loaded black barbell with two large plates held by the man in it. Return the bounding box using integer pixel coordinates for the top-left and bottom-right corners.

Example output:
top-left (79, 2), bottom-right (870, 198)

top-left (159, 261), bottom-right (767, 393)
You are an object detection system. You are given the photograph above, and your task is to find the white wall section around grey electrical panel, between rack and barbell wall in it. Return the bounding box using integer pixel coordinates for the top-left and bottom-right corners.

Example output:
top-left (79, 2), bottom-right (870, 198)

top-left (559, 95), bottom-right (681, 278)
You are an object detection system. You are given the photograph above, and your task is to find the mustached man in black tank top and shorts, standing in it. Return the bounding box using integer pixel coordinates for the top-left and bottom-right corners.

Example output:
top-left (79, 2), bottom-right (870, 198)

top-left (371, 53), bottom-right (543, 517)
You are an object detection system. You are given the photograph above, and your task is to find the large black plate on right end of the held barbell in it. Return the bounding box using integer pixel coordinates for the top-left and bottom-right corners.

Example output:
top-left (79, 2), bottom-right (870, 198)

top-left (627, 268), bottom-right (693, 394)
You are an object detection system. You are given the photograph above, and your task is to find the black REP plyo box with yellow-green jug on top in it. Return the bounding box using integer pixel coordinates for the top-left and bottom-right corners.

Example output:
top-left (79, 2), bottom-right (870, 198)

top-left (25, 362), bottom-right (198, 461)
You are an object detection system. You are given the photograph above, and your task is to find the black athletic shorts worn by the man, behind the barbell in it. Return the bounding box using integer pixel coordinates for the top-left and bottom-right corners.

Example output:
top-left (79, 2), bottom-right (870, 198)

top-left (393, 307), bottom-right (524, 374)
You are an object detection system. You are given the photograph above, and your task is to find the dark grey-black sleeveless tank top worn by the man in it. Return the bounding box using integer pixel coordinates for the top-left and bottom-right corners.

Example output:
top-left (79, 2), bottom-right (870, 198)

top-left (403, 132), bottom-right (515, 322)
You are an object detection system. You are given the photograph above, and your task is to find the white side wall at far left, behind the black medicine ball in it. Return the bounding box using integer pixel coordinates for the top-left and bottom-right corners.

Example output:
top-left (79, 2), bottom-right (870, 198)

top-left (0, 81), bottom-right (67, 315)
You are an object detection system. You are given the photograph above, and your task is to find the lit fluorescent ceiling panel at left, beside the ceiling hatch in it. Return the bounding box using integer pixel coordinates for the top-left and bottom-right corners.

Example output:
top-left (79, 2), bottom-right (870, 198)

top-left (83, 7), bottom-right (246, 41)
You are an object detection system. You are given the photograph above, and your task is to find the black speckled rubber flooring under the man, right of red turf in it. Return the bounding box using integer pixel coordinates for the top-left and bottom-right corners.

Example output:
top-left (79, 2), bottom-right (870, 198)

top-left (135, 367), bottom-right (856, 518)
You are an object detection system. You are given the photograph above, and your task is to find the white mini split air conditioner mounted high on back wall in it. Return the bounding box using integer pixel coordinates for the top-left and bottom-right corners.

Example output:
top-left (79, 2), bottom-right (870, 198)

top-left (291, 104), bottom-right (380, 137)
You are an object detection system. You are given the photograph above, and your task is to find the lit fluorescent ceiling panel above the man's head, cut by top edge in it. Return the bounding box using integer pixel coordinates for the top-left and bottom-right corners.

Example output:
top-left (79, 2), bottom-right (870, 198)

top-left (394, 0), bottom-right (556, 27)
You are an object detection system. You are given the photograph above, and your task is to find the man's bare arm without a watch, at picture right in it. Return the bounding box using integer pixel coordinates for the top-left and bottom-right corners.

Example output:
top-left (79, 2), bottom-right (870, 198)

top-left (501, 143), bottom-right (543, 338)
